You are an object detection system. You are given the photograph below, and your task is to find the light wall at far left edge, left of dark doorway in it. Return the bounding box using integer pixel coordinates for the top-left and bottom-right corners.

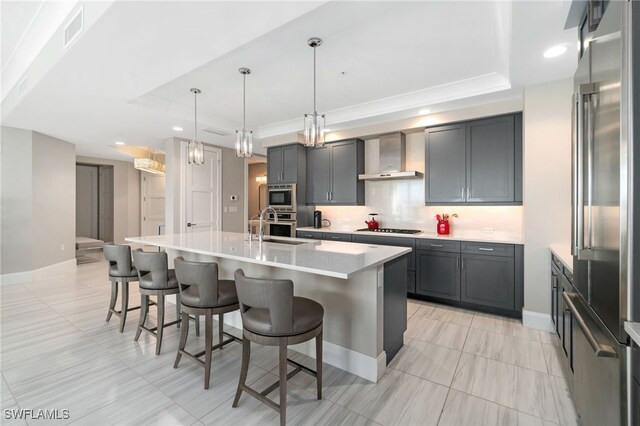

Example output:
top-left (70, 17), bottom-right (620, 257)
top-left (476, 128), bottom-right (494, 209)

top-left (0, 127), bottom-right (75, 274)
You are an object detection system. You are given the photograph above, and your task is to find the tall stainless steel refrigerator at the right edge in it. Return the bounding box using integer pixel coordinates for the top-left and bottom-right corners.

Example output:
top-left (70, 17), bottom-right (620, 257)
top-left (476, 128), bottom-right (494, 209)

top-left (563, 1), bottom-right (640, 425)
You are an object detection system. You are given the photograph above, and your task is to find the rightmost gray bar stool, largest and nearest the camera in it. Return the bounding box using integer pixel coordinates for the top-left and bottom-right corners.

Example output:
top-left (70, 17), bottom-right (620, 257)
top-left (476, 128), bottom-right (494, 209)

top-left (232, 269), bottom-right (324, 425)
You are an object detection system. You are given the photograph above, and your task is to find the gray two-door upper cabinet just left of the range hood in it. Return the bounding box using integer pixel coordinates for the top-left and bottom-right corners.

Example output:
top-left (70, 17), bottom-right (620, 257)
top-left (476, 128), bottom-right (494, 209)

top-left (307, 139), bottom-right (364, 206)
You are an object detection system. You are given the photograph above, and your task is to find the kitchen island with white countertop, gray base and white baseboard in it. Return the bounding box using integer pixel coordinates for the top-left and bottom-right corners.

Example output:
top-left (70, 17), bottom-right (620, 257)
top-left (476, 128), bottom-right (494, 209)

top-left (126, 232), bottom-right (411, 382)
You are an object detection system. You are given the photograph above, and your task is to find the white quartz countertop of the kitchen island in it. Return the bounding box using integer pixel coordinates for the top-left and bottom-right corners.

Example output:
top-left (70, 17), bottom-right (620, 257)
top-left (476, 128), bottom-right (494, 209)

top-left (126, 232), bottom-right (411, 279)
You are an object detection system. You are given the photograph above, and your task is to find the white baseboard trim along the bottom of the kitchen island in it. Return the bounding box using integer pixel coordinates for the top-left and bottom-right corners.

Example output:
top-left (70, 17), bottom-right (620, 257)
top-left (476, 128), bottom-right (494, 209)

top-left (219, 311), bottom-right (387, 383)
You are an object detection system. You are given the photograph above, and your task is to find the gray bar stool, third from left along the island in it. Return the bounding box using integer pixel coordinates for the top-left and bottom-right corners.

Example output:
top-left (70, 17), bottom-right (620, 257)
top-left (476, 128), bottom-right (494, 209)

top-left (173, 257), bottom-right (241, 389)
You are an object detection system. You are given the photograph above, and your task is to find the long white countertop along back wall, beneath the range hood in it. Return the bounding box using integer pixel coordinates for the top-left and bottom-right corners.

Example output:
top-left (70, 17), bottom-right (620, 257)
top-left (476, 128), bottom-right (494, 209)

top-left (297, 226), bottom-right (524, 244)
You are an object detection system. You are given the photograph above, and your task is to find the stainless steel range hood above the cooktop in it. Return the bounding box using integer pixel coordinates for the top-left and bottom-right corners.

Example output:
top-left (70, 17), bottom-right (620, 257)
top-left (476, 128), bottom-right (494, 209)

top-left (358, 132), bottom-right (422, 180)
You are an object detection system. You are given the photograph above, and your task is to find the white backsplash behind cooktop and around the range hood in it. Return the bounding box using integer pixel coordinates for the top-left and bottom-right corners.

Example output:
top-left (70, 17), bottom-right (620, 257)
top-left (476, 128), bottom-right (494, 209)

top-left (317, 133), bottom-right (523, 235)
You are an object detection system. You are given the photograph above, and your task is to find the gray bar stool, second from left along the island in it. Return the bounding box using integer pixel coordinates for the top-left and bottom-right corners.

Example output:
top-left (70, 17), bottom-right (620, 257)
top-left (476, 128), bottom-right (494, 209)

top-left (133, 249), bottom-right (180, 355)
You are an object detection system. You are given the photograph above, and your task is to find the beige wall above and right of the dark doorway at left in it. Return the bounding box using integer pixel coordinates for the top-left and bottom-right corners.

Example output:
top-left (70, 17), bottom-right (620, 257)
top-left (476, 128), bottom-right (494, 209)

top-left (76, 156), bottom-right (140, 244)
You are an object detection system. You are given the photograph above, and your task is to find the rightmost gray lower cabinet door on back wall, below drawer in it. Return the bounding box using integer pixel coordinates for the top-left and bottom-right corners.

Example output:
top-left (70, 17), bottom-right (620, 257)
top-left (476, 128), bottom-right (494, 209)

top-left (460, 254), bottom-right (515, 310)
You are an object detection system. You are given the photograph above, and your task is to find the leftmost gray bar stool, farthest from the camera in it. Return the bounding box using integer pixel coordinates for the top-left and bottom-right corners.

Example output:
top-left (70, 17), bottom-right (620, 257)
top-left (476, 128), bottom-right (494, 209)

top-left (102, 244), bottom-right (146, 333)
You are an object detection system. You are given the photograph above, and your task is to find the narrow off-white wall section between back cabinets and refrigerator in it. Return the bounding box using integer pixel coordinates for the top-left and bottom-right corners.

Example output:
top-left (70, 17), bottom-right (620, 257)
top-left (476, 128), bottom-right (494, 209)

top-left (523, 78), bottom-right (573, 320)
